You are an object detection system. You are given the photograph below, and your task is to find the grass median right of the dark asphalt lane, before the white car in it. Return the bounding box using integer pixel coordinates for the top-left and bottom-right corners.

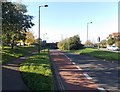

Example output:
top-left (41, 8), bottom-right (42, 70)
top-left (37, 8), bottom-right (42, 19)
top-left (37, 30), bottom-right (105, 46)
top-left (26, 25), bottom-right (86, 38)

top-left (70, 48), bottom-right (120, 60)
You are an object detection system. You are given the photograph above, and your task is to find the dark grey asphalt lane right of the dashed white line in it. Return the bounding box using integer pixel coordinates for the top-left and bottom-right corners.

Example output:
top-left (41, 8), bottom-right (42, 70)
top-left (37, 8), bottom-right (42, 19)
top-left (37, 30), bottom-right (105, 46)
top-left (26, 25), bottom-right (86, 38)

top-left (61, 51), bottom-right (120, 92)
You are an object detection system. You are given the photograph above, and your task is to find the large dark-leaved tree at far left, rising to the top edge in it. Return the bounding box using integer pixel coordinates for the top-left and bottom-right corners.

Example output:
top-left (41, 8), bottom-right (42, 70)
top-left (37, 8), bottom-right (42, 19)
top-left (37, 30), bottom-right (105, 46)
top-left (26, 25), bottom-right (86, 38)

top-left (2, 2), bottom-right (34, 48)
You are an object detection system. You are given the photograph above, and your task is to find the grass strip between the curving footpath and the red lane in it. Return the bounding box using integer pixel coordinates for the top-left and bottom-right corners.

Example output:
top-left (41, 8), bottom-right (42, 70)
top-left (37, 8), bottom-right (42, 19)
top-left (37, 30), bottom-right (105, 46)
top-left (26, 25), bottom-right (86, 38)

top-left (19, 51), bottom-right (53, 91)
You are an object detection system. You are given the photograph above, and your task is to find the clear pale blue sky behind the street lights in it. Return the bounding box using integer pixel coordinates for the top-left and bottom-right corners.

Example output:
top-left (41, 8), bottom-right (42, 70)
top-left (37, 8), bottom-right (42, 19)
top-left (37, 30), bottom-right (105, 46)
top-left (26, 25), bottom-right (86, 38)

top-left (22, 2), bottom-right (118, 43)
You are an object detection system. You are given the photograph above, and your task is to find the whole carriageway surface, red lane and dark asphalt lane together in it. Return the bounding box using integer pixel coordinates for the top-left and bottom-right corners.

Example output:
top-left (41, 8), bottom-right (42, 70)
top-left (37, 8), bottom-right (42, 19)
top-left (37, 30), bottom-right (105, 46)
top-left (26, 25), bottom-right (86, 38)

top-left (50, 50), bottom-right (119, 92)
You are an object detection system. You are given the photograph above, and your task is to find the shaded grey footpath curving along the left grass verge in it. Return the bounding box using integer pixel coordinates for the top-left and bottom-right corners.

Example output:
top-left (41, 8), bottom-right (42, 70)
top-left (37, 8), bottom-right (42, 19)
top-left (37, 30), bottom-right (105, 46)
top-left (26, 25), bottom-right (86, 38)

top-left (2, 52), bottom-right (36, 92)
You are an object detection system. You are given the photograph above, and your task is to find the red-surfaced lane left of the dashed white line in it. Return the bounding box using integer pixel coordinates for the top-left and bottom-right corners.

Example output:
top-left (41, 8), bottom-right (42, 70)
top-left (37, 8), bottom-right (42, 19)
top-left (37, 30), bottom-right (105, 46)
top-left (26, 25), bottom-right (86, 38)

top-left (50, 51), bottom-right (100, 92)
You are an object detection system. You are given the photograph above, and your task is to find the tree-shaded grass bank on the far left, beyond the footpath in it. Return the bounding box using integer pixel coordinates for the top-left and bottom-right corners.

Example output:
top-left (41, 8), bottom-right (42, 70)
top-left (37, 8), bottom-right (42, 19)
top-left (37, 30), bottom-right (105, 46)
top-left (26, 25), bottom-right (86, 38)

top-left (1, 46), bottom-right (36, 64)
